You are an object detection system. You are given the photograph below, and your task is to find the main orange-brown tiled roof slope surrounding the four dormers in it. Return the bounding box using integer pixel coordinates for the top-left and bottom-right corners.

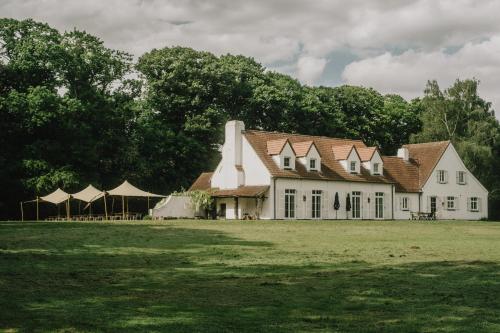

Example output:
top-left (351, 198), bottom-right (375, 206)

top-left (243, 130), bottom-right (392, 183)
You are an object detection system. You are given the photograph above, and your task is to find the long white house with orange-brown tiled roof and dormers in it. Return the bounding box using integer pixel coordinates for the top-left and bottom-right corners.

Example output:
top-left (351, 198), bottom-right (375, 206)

top-left (178, 121), bottom-right (488, 220)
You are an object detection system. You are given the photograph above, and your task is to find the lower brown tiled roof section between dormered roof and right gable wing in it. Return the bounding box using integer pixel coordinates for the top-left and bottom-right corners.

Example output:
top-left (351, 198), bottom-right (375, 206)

top-left (382, 156), bottom-right (420, 192)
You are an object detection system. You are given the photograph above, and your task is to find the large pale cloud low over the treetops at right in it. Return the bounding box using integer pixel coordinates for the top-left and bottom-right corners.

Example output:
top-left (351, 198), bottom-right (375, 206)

top-left (342, 35), bottom-right (500, 114)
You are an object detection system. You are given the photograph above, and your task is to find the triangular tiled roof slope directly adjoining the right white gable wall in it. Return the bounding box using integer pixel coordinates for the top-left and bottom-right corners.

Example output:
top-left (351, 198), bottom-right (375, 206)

top-left (403, 141), bottom-right (450, 188)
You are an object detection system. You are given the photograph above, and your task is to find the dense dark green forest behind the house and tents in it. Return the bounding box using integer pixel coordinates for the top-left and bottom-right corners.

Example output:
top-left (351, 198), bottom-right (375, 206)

top-left (0, 19), bottom-right (500, 219)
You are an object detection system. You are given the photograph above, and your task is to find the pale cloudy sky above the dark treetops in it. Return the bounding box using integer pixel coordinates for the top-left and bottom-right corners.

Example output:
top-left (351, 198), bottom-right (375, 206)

top-left (0, 0), bottom-right (500, 117)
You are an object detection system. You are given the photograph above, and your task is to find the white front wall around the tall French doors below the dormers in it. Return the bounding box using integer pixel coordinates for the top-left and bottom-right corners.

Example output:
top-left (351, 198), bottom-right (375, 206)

top-left (276, 178), bottom-right (393, 219)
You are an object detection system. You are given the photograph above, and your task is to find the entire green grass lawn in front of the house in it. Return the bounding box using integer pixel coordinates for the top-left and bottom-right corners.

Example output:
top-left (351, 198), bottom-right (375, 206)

top-left (0, 221), bottom-right (500, 333)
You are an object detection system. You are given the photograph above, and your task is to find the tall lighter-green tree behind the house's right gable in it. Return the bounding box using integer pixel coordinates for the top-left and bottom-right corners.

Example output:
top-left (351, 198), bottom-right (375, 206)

top-left (412, 79), bottom-right (500, 218)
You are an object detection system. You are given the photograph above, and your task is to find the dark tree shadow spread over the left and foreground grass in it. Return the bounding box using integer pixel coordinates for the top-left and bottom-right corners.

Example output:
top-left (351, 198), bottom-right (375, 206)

top-left (0, 223), bottom-right (500, 332)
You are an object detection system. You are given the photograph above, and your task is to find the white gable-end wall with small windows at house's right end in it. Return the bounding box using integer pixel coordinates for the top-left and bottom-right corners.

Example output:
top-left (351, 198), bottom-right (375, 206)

top-left (421, 144), bottom-right (488, 220)
